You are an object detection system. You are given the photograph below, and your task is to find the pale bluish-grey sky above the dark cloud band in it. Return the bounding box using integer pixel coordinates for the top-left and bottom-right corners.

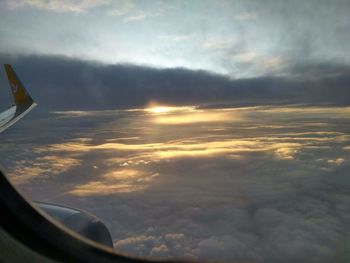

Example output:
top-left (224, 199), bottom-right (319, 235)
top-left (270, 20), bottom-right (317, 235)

top-left (0, 0), bottom-right (350, 78)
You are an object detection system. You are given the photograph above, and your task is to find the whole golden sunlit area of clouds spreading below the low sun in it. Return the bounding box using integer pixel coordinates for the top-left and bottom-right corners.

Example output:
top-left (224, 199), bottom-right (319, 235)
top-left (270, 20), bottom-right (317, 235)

top-left (9, 106), bottom-right (350, 195)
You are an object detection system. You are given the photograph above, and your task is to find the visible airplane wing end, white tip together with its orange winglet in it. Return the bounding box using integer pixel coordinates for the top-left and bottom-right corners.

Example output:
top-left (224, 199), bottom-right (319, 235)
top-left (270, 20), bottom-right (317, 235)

top-left (0, 64), bottom-right (37, 133)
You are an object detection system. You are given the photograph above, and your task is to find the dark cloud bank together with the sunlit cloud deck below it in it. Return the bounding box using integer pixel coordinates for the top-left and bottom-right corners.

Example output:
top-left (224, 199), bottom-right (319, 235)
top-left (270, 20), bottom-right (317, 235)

top-left (0, 48), bottom-right (350, 263)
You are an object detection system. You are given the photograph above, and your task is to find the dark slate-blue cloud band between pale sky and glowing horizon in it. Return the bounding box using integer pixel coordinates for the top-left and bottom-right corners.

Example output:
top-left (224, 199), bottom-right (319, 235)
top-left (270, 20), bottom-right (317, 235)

top-left (0, 55), bottom-right (350, 109)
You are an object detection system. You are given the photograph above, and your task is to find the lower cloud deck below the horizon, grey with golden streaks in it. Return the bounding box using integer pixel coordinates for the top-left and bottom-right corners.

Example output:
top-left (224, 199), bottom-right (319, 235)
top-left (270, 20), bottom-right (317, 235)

top-left (0, 106), bottom-right (350, 263)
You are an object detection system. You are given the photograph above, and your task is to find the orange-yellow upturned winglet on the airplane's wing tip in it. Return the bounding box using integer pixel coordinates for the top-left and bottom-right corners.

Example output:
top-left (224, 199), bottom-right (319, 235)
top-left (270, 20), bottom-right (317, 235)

top-left (4, 64), bottom-right (34, 109)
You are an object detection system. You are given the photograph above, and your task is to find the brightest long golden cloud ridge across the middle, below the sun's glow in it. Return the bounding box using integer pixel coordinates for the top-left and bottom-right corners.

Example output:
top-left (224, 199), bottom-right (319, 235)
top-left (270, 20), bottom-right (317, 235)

top-left (56, 138), bottom-right (300, 160)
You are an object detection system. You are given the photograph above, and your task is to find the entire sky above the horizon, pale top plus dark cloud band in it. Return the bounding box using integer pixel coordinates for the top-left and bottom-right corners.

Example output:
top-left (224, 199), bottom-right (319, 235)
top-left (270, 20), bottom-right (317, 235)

top-left (0, 0), bottom-right (350, 110)
